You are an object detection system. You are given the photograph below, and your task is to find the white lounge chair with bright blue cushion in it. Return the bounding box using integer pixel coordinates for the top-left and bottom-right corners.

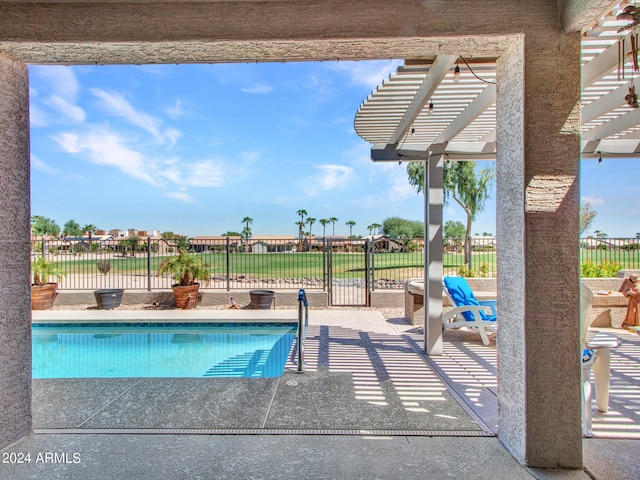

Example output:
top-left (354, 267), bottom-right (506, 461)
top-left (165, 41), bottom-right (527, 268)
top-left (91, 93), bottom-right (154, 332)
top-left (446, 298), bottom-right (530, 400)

top-left (442, 277), bottom-right (497, 345)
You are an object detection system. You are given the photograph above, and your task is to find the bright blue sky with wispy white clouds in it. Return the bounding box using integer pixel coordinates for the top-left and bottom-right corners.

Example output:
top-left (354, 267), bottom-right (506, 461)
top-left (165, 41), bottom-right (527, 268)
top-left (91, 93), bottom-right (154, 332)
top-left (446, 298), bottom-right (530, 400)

top-left (30, 60), bottom-right (640, 237)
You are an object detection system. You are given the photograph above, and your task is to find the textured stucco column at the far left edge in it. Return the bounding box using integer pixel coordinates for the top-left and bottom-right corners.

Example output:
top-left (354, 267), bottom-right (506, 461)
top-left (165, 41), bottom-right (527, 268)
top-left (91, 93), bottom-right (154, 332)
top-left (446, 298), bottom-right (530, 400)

top-left (0, 57), bottom-right (31, 448)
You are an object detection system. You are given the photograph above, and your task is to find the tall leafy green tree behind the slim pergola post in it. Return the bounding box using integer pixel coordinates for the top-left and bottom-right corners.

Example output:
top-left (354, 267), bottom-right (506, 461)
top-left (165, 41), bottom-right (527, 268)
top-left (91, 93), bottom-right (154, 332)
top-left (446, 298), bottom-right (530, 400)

top-left (407, 161), bottom-right (495, 264)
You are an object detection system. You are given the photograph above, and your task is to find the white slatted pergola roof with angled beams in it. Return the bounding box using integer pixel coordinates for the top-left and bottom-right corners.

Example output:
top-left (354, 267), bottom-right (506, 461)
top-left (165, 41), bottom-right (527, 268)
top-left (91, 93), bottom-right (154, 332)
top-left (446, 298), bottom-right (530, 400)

top-left (354, 2), bottom-right (640, 161)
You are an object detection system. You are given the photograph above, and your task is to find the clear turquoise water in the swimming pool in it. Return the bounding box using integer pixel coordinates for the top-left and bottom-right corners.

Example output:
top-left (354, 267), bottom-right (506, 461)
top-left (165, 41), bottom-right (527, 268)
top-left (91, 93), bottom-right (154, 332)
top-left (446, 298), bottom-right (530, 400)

top-left (32, 323), bottom-right (295, 378)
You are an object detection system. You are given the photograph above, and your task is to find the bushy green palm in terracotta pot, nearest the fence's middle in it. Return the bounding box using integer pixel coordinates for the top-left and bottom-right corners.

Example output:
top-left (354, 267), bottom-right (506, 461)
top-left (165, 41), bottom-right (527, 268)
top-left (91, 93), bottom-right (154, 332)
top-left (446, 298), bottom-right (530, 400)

top-left (158, 248), bottom-right (211, 309)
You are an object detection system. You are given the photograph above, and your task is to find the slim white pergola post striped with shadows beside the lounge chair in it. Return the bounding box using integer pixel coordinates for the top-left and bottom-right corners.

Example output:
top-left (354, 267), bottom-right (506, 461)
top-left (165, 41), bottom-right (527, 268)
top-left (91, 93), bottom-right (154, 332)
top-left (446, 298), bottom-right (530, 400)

top-left (424, 149), bottom-right (444, 355)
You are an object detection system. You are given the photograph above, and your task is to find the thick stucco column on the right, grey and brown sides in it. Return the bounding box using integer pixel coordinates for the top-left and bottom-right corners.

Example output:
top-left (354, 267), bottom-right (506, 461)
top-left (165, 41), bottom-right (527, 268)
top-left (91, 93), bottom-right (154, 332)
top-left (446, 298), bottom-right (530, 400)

top-left (496, 31), bottom-right (582, 468)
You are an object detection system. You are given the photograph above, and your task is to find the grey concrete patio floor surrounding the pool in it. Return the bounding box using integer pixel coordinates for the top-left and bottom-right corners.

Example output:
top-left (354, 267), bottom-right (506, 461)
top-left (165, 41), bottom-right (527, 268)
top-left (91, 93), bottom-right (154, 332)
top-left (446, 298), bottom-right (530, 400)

top-left (0, 310), bottom-right (640, 479)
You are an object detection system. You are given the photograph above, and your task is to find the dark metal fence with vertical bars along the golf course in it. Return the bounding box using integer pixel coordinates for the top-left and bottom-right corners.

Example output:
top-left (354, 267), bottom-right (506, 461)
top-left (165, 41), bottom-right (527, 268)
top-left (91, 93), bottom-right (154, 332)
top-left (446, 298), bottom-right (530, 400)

top-left (32, 237), bottom-right (640, 290)
